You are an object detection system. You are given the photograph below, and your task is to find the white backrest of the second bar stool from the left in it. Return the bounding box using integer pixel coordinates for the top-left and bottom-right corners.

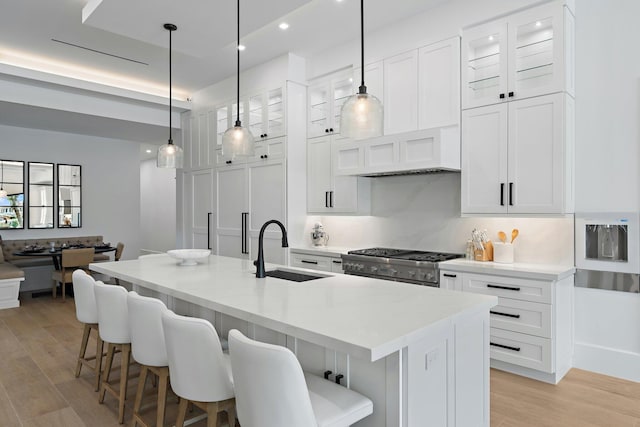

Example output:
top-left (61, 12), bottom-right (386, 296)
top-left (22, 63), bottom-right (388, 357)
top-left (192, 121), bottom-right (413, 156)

top-left (94, 281), bottom-right (131, 344)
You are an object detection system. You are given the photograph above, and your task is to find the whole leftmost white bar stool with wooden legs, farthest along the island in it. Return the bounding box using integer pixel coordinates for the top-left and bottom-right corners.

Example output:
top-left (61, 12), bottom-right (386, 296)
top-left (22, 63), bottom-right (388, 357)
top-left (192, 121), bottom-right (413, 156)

top-left (72, 270), bottom-right (104, 391)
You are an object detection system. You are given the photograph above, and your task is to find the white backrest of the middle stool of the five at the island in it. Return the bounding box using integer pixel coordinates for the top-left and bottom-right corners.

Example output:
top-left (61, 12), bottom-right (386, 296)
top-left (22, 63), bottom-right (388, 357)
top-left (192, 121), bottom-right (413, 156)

top-left (127, 292), bottom-right (169, 366)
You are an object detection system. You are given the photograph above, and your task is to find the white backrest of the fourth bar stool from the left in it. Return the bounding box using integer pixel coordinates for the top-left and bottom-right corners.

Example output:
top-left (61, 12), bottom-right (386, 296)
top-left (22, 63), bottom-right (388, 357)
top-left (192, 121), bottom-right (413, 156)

top-left (162, 310), bottom-right (234, 402)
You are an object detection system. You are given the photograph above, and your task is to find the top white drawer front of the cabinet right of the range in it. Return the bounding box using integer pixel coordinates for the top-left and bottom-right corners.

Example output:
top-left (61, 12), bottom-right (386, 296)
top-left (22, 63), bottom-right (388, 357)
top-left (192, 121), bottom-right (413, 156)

top-left (462, 273), bottom-right (553, 304)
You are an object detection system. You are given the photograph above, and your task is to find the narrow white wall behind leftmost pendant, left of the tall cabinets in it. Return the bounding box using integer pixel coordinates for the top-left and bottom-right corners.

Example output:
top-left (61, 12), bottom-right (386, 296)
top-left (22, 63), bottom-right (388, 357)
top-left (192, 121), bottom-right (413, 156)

top-left (140, 159), bottom-right (177, 253)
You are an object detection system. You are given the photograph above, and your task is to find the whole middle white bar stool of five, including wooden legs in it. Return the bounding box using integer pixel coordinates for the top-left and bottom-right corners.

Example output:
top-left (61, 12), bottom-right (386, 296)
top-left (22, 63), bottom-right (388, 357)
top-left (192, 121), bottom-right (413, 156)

top-left (127, 292), bottom-right (169, 427)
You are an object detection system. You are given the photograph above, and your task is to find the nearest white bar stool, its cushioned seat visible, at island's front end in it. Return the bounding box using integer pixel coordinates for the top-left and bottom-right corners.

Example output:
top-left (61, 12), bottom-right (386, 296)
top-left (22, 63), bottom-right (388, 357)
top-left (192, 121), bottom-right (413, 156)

top-left (229, 329), bottom-right (373, 427)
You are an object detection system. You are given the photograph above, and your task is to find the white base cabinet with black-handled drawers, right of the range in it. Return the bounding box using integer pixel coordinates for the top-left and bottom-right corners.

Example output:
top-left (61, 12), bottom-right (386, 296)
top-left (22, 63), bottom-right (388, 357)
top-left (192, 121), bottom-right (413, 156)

top-left (440, 264), bottom-right (573, 383)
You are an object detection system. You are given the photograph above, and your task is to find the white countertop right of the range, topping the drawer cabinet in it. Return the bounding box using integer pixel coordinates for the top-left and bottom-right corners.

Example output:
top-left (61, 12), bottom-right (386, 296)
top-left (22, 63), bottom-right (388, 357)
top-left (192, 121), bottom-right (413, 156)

top-left (438, 258), bottom-right (576, 280)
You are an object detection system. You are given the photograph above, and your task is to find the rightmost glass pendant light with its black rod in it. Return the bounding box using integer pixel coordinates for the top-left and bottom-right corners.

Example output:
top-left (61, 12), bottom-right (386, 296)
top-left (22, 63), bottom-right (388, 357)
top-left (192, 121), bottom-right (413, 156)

top-left (340, 0), bottom-right (384, 139)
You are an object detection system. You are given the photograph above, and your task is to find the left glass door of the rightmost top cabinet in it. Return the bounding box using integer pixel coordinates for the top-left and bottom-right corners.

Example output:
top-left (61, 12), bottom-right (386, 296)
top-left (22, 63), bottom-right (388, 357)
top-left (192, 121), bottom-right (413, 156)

top-left (461, 23), bottom-right (507, 108)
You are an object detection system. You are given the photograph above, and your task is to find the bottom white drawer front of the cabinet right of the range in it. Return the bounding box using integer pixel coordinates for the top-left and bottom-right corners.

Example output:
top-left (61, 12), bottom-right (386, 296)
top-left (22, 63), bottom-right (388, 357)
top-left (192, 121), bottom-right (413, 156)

top-left (489, 328), bottom-right (554, 373)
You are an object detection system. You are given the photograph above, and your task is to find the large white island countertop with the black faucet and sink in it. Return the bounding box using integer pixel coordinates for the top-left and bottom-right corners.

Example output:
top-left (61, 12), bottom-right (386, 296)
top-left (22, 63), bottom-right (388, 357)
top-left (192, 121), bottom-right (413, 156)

top-left (89, 254), bottom-right (498, 361)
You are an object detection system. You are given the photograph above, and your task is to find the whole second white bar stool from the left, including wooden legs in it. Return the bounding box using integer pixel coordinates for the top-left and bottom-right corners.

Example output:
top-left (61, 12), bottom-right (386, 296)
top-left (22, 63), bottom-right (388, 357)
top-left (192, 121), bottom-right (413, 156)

top-left (94, 281), bottom-right (131, 424)
